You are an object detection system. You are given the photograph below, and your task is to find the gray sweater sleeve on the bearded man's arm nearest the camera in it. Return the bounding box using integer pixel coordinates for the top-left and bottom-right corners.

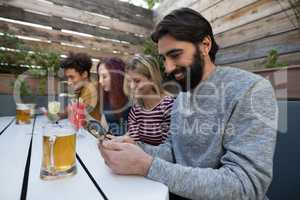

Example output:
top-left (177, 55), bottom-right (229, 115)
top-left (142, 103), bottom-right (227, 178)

top-left (147, 80), bottom-right (278, 200)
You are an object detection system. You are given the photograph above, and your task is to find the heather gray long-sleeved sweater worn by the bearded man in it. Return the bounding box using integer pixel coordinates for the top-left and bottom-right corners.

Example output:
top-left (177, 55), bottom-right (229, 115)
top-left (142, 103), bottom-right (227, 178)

top-left (141, 67), bottom-right (278, 200)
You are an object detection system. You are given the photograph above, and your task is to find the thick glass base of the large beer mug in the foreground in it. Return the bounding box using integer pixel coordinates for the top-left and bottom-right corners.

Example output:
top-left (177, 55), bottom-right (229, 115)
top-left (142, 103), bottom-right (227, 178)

top-left (40, 165), bottom-right (77, 180)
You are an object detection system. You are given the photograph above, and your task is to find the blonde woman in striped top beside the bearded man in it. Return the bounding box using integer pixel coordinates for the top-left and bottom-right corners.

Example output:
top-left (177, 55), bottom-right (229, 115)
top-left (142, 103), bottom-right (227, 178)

top-left (124, 55), bottom-right (174, 145)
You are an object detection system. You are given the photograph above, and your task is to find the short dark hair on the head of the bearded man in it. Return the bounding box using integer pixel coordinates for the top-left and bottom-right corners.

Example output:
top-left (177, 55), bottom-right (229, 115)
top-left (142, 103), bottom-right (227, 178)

top-left (151, 8), bottom-right (219, 62)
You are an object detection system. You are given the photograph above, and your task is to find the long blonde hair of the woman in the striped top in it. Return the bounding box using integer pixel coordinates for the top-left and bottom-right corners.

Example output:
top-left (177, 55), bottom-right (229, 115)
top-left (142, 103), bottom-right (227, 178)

top-left (123, 54), bottom-right (168, 103)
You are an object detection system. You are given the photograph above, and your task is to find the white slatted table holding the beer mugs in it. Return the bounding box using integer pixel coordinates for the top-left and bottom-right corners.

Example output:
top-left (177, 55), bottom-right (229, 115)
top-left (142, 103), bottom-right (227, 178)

top-left (0, 117), bottom-right (169, 200)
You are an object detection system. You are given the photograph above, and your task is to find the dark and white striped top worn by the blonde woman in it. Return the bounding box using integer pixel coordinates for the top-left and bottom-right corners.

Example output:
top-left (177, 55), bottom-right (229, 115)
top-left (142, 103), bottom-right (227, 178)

top-left (128, 96), bottom-right (174, 146)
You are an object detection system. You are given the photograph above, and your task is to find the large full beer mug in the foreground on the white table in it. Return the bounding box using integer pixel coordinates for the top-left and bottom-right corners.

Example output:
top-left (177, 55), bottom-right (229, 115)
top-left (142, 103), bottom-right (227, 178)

top-left (40, 120), bottom-right (77, 180)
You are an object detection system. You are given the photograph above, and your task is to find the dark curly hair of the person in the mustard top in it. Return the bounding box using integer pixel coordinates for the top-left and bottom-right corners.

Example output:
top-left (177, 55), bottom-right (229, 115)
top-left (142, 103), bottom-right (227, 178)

top-left (60, 52), bottom-right (93, 77)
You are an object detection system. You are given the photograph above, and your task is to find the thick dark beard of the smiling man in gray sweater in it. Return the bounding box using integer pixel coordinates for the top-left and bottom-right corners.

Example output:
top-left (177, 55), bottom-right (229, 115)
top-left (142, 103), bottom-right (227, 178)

top-left (170, 48), bottom-right (204, 92)
